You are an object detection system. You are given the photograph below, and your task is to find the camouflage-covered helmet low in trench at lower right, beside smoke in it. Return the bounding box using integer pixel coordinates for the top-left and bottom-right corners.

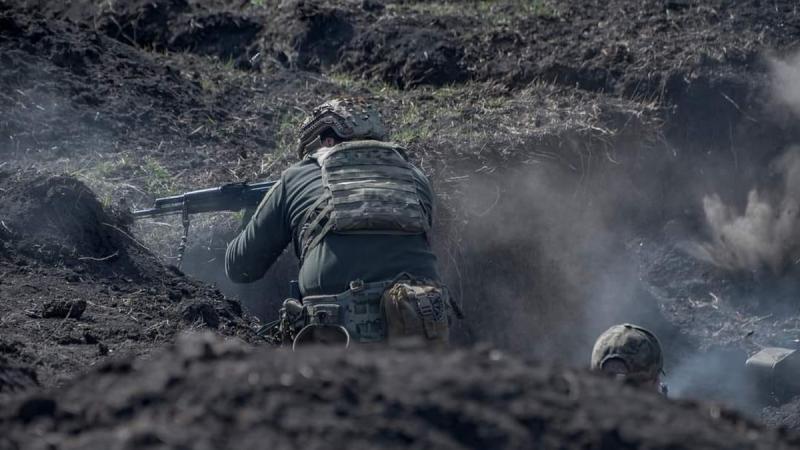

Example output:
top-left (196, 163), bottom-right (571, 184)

top-left (592, 323), bottom-right (664, 380)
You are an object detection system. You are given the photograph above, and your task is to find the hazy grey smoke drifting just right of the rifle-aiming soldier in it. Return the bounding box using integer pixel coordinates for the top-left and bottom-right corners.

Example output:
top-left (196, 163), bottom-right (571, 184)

top-left (439, 151), bottom-right (658, 366)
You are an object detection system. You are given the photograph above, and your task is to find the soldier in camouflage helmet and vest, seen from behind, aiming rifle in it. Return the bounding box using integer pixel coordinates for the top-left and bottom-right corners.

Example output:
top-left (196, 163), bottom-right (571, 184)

top-left (225, 99), bottom-right (450, 345)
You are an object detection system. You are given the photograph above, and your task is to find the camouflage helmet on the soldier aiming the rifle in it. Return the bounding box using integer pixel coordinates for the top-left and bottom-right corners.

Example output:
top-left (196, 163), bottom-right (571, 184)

top-left (297, 99), bottom-right (386, 158)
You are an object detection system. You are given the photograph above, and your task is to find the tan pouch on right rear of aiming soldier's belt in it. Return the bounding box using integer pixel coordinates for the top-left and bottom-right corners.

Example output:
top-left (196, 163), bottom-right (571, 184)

top-left (381, 280), bottom-right (450, 343)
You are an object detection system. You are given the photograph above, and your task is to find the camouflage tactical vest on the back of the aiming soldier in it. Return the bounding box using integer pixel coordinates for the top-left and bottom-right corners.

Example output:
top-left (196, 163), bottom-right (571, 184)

top-left (300, 141), bottom-right (430, 261)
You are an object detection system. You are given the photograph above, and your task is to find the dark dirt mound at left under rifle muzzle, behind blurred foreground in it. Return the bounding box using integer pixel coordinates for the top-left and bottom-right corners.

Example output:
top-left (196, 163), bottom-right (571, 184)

top-left (0, 171), bottom-right (257, 390)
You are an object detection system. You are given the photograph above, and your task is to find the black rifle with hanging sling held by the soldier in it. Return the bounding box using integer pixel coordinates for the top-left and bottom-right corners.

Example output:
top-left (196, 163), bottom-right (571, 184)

top-left (133, 181), bottom-right (277, 265)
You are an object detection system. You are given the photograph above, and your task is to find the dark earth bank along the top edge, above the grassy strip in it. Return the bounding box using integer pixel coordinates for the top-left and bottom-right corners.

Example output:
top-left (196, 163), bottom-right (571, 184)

top-left (14, 0), bottom-right (800, 145)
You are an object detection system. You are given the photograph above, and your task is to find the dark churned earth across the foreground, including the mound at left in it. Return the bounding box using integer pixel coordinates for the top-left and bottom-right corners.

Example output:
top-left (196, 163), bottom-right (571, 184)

top-left (0, 172), bottom-right (800, 449)
